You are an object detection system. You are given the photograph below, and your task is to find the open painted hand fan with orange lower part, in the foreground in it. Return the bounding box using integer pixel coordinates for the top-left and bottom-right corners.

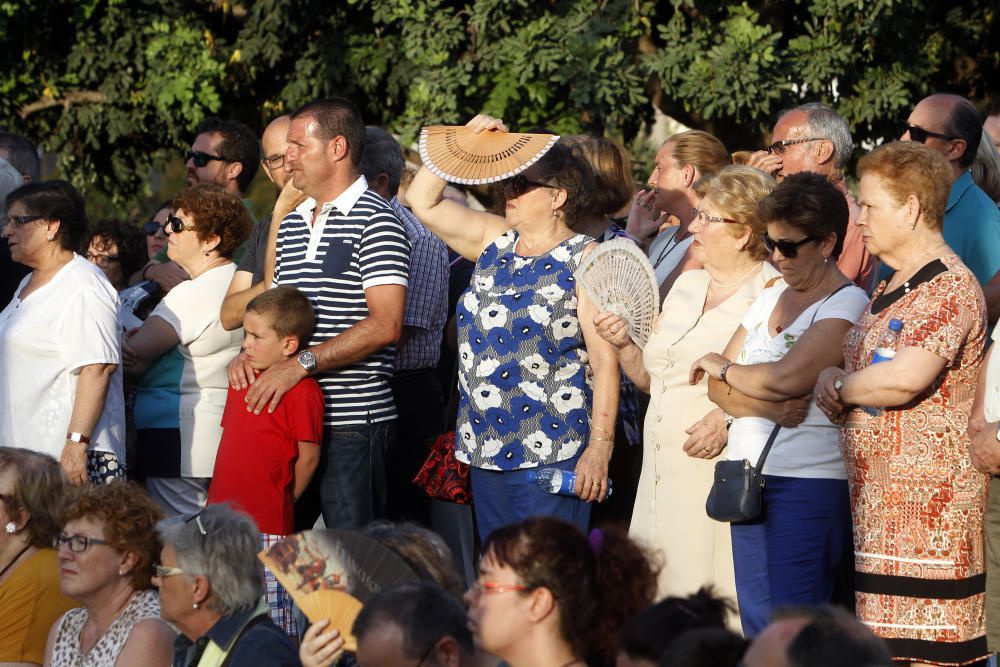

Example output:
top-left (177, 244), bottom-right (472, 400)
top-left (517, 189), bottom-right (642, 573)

top-left (258, 530), bottom-right (418, 651)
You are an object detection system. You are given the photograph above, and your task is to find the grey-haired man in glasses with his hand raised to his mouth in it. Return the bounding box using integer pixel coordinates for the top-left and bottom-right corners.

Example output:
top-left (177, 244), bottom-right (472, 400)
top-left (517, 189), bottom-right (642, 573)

top-left (750, 102), bottom-right (877, 292)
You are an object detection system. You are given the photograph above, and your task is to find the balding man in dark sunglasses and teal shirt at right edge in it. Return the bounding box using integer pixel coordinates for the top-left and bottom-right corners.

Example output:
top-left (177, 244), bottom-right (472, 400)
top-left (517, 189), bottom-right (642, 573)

top-left (900, 94), bottom-right (1000, 294)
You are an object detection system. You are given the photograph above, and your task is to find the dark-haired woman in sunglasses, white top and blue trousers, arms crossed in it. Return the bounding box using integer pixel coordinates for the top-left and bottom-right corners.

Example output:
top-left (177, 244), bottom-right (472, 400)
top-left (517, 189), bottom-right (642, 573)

top-left (690, 172), bottom-right (868, 637)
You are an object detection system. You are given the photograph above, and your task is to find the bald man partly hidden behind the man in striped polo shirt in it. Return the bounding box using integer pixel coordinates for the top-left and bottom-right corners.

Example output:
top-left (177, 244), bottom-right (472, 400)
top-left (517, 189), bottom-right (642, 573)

top-left (219, 115), bottom-right (291, 331)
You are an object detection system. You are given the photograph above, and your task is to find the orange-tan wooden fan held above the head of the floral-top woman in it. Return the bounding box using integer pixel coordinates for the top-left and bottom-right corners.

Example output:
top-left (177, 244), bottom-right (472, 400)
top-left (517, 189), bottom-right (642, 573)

top-left (420, 125), bottom-right (559, 185)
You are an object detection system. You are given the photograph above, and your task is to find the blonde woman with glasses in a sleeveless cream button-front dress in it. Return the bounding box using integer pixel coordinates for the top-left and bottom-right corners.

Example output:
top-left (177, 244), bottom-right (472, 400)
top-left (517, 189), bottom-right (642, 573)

top-left (595, 166), bottom-right (788, 597)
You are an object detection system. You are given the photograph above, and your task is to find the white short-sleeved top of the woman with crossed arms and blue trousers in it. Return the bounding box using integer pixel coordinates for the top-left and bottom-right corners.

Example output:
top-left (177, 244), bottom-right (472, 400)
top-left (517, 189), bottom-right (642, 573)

top-left (726, 282), bottom-right (868, 479)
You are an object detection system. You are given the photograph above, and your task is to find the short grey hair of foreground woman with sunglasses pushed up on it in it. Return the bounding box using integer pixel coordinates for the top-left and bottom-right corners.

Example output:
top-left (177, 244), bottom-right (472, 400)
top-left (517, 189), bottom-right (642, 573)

top-left (156, 505), bottom-right (264, 616)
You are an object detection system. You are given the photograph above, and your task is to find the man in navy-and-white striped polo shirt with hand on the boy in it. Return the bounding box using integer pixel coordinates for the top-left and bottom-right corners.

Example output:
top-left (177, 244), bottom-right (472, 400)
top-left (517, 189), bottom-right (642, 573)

top-left (247, 98), bottom-right (410, 529)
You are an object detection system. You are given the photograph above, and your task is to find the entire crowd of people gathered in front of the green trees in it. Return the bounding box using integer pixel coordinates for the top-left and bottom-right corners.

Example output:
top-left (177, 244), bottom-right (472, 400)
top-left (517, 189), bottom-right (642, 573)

top-left (0, 94), bottom-right (1000, 667)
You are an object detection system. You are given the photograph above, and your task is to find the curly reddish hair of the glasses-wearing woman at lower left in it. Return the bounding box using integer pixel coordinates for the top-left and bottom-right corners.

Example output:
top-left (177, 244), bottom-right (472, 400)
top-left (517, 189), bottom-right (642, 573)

top-left (62, 482), bottom-right (163, 591)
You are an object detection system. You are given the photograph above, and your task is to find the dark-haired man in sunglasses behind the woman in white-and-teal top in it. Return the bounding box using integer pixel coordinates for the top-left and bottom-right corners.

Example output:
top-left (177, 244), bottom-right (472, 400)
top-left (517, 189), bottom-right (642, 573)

top-left (142, 117), bottom-right (261, 294)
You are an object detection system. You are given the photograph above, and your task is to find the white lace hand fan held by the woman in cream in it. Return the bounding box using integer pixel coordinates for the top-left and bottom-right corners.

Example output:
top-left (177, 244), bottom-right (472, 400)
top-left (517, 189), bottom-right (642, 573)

top-left (575, 239), bottom-right (660, 347)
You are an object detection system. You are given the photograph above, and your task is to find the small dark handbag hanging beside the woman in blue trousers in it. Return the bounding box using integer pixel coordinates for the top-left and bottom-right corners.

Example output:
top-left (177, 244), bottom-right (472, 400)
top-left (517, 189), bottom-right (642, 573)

top-left (705, 424), bottom-right (781, 523)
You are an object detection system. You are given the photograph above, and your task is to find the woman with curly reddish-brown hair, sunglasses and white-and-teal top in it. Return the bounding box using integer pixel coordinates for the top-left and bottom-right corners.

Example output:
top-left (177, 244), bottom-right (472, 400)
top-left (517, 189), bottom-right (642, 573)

top-left (124, 185), bottom-right (252, 514)
